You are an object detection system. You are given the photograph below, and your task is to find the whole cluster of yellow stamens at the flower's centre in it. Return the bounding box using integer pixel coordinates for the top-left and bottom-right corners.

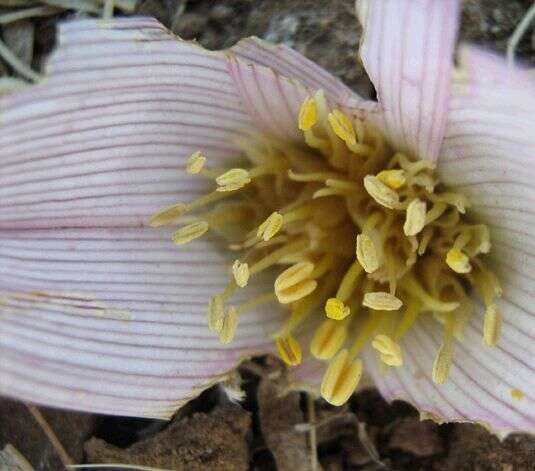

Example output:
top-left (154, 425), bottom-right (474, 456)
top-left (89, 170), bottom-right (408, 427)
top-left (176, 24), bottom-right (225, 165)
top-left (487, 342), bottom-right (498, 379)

top-left (151, 91), bottom-right (501, 404)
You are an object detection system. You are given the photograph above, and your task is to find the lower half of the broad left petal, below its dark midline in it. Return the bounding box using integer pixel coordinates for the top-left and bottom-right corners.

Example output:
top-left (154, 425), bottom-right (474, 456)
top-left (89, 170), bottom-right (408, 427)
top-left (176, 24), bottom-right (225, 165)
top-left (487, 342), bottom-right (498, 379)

top-left (0, 228), bottom-right (283, 418)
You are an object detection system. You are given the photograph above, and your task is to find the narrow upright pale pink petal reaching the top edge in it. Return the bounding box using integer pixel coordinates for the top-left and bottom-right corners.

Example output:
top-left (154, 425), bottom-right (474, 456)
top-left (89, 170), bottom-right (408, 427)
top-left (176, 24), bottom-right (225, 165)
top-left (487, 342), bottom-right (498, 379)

top-left (357, 0), bottom-right (459, 160)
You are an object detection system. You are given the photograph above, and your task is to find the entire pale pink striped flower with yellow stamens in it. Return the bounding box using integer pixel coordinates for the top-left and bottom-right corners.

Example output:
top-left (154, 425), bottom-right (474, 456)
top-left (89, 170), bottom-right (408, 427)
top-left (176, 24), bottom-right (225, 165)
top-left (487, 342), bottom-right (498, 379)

top-left (0, 0), bottom-right (535, 431)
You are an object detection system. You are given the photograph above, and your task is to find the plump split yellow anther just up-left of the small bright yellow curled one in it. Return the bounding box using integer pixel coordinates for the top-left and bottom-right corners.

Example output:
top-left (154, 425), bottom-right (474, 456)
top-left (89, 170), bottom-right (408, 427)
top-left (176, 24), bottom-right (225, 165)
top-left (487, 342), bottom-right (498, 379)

top-left (275, 262), bottom-right (318, 304)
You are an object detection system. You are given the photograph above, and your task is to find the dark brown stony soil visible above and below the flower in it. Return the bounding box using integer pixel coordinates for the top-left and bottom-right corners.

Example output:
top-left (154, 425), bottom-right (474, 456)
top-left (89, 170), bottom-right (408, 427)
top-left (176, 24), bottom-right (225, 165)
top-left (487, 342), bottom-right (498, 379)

top-left (0, 0), bottom-right (535, 471)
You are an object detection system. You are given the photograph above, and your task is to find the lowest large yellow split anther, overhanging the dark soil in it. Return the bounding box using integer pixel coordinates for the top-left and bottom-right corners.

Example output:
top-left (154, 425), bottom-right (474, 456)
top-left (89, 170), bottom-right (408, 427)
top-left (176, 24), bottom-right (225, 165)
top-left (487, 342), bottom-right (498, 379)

top-left (321, 349), bottom-right (362, 406)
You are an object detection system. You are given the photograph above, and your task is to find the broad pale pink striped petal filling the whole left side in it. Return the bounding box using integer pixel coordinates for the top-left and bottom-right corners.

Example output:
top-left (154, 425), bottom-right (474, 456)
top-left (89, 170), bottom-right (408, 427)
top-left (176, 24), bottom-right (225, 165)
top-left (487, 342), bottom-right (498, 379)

top-left (0, 18), bottom-right (330, 417)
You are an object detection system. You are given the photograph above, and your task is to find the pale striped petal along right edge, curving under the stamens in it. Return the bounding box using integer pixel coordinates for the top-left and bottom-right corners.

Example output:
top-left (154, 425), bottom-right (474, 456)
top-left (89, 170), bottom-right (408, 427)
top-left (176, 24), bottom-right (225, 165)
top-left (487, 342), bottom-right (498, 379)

top-left (368, 47), bottom-right (535, 432)
